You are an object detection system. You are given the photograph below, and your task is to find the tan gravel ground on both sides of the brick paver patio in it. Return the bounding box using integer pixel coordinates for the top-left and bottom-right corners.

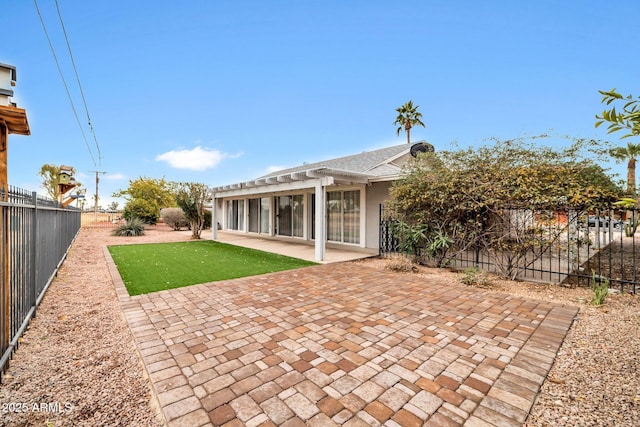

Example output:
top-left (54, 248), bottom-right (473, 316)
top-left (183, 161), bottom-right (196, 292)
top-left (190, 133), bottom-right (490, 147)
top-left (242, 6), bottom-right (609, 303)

top-left (0, 227), bottom-right (640, 427)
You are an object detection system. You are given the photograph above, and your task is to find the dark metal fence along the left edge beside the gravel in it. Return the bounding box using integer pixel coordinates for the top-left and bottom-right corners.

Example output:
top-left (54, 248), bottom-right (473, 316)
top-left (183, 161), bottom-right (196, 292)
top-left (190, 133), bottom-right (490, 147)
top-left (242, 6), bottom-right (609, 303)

top-left (0, 187), bottom-right (80, 373)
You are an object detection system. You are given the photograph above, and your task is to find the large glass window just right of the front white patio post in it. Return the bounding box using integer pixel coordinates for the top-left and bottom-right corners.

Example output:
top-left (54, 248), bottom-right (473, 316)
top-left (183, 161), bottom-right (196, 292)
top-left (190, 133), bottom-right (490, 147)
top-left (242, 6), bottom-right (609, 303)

top-left (327, 190), bottom-right (360, 243)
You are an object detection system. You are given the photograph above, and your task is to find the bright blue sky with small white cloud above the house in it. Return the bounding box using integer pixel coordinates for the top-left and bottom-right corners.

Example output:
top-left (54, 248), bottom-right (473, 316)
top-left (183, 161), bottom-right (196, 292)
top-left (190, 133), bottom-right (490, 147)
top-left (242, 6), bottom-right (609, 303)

top-left (0, 0), bottom-right (640, 207)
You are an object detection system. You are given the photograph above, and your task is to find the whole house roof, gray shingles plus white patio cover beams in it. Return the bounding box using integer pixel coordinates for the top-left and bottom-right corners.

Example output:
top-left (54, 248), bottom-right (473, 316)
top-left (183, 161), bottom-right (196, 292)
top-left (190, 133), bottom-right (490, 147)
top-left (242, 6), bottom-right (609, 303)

top-left (213, 144), bottom-right (415, 193)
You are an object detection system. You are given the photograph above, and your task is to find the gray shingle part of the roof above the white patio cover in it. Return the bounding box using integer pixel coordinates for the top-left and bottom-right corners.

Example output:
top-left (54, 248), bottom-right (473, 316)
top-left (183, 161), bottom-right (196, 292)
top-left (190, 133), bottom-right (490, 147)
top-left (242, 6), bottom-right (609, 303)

top-left (259, 144), bottom-right (411, 179)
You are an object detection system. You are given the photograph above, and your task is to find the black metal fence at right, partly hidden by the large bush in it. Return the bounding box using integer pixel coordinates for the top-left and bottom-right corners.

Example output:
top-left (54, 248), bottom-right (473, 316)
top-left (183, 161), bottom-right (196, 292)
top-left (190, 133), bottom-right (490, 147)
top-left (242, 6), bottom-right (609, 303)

top-left (380, 206), bottom-right (640, 293)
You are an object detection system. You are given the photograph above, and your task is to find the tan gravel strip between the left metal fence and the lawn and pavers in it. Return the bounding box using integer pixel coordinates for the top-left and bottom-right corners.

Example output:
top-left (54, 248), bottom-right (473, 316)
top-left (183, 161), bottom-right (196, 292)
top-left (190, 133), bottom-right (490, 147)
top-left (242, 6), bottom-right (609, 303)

top-left (0, 227), bottom-right (190, 426)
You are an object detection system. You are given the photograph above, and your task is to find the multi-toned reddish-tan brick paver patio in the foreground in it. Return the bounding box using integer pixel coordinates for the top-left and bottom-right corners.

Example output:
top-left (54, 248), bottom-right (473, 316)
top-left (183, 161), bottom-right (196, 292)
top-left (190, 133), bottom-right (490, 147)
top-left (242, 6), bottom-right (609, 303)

top-left (107, 256), bottom-right (578, 427)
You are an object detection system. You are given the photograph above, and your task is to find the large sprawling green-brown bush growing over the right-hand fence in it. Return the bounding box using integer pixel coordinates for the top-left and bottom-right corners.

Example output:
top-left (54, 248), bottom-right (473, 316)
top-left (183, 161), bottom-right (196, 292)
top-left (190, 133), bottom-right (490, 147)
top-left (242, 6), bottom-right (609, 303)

top-left (388, 135), bottom-right (622, 279)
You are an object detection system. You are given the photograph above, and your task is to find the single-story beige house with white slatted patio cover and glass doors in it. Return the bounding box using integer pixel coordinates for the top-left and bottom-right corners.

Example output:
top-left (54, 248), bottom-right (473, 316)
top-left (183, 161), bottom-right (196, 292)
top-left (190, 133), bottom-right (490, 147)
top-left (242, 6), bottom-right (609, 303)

top-left (212, 142), bottom-right (433, 261)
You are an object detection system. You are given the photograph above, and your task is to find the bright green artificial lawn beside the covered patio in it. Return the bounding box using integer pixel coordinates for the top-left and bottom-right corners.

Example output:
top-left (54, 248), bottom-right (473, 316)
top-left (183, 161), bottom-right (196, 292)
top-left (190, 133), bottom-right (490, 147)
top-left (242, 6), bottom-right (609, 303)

top-left (109, 240), bottom-right (315, 295)
